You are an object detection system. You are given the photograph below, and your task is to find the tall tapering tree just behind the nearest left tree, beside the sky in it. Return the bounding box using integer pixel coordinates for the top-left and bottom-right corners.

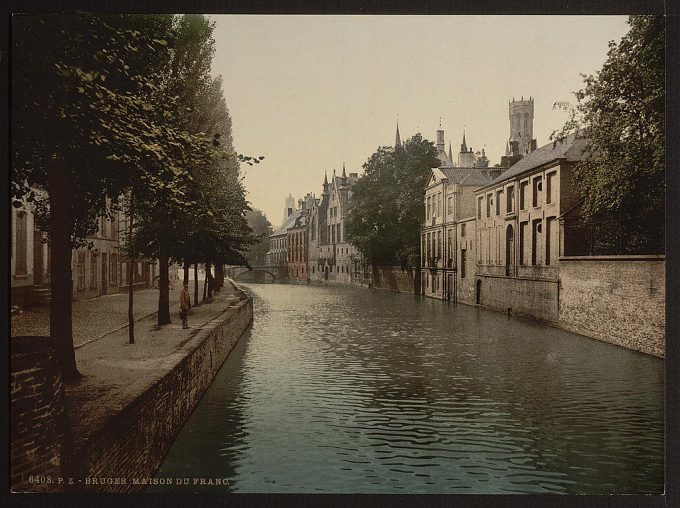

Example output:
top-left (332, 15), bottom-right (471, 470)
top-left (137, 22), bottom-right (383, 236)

top-left (131, 15), bottom-right (263, 325)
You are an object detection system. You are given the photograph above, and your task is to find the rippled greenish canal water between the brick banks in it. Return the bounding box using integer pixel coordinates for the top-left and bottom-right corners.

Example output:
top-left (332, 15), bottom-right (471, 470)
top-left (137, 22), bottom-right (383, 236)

top-left (148, 284), bottom-right (664, 494)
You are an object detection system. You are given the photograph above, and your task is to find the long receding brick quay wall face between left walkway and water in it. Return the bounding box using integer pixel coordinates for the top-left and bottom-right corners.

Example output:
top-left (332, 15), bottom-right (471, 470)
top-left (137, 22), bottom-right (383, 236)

top-left (73, 297), bottom-right (253, 492)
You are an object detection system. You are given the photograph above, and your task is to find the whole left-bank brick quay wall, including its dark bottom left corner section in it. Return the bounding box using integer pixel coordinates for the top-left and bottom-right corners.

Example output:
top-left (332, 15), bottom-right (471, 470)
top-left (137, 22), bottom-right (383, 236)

top-left (10, 288), bottom-right (253, 493)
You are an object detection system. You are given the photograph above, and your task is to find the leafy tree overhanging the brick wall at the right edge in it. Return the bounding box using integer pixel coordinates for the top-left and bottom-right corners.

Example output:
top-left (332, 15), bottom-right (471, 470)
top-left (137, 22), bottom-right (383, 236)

top-left (553, 16), bottom-right (665, 253)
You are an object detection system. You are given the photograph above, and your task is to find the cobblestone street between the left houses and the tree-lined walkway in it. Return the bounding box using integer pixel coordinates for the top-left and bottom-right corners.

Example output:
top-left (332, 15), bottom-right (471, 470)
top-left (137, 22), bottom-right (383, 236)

top-left (11, 285), bottom-right (218, 346)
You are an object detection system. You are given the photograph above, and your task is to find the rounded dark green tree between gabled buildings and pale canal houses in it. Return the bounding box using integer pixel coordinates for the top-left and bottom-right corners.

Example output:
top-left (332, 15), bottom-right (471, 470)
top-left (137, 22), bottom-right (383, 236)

top-left (347, 134), bottom-right (440, 268)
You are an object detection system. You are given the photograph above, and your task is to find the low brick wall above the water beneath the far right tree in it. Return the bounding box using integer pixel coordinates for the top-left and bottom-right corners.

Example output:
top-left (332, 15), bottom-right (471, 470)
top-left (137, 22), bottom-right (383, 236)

top-left (558, 256), bottom-right (666, 357)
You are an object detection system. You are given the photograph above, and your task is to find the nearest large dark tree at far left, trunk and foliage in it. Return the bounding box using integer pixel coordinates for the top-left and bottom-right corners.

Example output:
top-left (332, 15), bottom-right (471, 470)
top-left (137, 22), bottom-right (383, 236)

top-left (12, 14), bottom-right (193, 380)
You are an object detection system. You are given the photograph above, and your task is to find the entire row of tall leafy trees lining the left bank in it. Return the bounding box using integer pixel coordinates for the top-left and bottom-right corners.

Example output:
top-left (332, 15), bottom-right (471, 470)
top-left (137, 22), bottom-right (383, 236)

top-left (12, 14), bottom-right (260, 379)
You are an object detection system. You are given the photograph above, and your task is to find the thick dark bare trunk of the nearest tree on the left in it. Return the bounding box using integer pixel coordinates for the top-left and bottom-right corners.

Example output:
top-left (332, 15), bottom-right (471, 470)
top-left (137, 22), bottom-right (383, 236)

top-left (49, 169), bottom-right (81, 381)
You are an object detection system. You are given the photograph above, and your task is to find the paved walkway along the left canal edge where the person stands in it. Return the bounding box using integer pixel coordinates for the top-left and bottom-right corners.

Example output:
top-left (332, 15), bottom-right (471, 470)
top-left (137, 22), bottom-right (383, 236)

top-left (66, 281), bottom-right (244, 449)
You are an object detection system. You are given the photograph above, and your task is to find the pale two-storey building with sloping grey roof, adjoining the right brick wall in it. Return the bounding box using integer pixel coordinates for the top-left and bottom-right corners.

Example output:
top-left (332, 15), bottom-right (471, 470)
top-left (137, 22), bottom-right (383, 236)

top-left (475, 135), bottom-right (587, 321)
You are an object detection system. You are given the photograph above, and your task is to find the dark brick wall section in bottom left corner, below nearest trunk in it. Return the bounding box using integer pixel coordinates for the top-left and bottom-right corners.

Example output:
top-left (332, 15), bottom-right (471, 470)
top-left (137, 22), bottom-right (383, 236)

top-left (10, 337), bottom-right (70, 492)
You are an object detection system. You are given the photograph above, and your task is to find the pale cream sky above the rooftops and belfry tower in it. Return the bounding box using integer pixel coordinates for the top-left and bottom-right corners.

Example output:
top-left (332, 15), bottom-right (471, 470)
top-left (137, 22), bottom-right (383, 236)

top-left (211, 15), bottom-right (627, 228)
